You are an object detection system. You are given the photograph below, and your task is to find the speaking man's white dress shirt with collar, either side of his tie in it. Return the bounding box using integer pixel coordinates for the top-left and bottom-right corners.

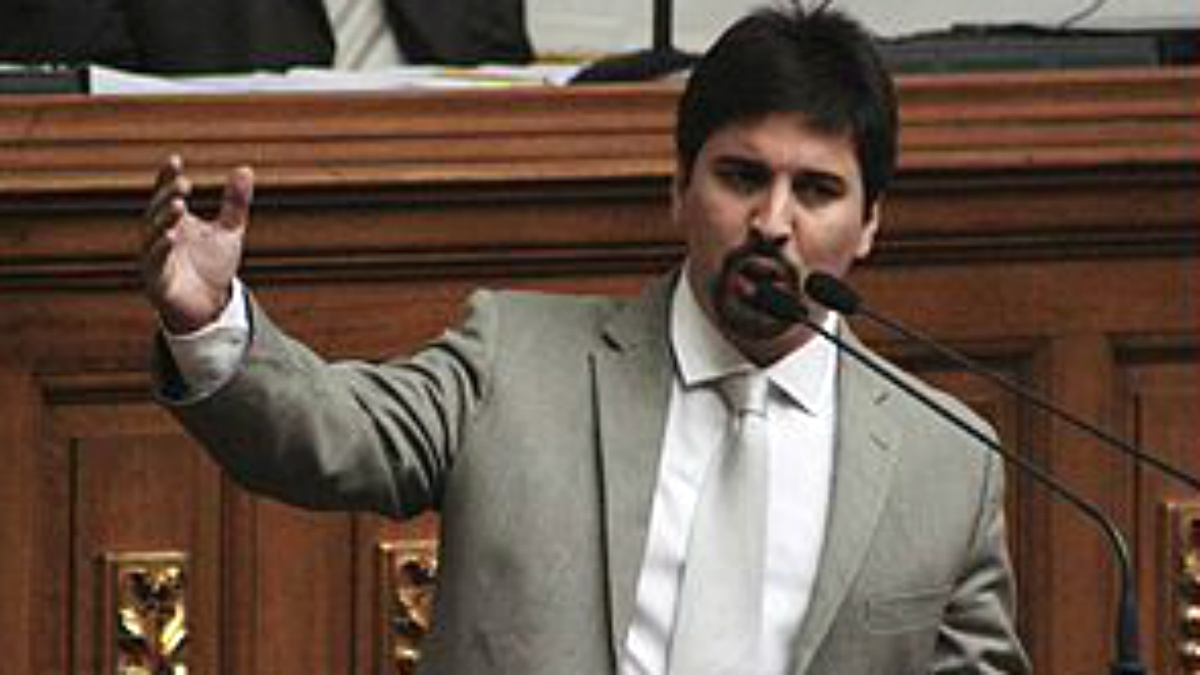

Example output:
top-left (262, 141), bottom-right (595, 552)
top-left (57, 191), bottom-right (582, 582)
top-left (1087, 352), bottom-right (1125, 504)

top-left (619, 275), bottom-right (838, 675)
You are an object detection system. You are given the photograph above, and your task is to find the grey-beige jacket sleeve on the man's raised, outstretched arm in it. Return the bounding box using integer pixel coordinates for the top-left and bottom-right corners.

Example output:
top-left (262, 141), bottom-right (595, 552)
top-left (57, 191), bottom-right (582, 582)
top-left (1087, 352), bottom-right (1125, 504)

top-left (155, 288), bottom-right (496, 516)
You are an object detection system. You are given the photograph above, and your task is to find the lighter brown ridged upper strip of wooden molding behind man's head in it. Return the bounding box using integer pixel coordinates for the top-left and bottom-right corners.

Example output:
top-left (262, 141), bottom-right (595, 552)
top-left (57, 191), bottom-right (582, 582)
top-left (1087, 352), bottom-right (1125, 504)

top-left (0, 68), bottom-right (1200, 192)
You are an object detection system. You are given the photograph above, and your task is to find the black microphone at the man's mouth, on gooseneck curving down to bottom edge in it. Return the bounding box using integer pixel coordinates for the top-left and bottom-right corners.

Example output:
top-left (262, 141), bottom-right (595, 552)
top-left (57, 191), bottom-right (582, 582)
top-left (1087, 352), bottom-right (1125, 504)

top-left (754, 281), bottom-right (1146, 675)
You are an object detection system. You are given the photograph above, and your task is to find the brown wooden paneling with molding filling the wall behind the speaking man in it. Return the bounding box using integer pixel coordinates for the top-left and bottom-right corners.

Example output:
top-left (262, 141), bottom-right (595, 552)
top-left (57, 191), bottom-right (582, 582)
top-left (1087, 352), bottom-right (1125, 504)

top-left (0, 68), bottom-right (1200, 675)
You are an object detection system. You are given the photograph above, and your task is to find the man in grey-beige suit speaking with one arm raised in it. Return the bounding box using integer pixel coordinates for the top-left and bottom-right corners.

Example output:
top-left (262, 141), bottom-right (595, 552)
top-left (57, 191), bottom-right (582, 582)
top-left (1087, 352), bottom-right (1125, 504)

top-left (143, 6), bottom-right (1027, 675)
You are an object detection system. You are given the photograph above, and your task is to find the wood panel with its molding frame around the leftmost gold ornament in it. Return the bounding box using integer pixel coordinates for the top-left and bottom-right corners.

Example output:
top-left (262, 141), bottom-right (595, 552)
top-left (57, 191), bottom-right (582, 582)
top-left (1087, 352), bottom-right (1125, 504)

top-left (45, 372), bottom-right (222, 673)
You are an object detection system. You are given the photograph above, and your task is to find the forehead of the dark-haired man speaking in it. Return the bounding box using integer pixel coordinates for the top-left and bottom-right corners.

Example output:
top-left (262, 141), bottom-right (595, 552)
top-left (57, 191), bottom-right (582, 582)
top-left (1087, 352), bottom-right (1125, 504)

top-left (701, 113), bottom-right (859, 178)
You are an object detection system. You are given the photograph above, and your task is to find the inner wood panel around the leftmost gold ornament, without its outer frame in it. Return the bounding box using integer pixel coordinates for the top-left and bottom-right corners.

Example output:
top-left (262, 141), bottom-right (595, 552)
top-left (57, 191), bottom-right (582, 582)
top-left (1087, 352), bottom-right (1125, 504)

top-left (66, 429), bottom-right (221, 675)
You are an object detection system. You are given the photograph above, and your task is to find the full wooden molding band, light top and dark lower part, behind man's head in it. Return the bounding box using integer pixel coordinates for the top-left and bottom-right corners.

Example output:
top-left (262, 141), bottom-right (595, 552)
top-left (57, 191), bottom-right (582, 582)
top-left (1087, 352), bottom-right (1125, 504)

top-left (0, 68), bottom-right (1200, 291)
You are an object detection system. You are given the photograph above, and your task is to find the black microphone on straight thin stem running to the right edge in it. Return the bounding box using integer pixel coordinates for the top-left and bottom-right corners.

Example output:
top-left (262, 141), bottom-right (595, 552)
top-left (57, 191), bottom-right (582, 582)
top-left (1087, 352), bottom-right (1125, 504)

top-left (804, 271), bottom-right (1200, 491)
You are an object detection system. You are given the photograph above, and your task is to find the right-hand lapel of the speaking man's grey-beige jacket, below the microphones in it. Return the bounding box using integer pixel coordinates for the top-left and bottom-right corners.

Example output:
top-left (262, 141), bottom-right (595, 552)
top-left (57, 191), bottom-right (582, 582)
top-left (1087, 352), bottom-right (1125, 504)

top-left (794, 330), bottom-right (901, 673)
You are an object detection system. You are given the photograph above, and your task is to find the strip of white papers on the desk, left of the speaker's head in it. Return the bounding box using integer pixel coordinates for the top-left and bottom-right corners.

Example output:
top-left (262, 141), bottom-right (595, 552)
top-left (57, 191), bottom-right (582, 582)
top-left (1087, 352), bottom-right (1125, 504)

top-left (88, 65), bottom-right (578, 95)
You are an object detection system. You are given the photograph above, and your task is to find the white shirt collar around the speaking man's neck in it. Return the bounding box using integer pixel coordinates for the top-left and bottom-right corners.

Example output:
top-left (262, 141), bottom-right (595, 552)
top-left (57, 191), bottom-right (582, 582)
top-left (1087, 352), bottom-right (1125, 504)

top-left (671, 271), bottom-right (839, 413)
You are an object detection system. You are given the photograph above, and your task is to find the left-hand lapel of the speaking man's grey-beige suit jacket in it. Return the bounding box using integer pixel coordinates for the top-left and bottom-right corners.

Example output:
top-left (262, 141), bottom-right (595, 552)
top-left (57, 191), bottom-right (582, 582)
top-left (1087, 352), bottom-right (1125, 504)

top-left (592, 277), bottom-right (673, 658)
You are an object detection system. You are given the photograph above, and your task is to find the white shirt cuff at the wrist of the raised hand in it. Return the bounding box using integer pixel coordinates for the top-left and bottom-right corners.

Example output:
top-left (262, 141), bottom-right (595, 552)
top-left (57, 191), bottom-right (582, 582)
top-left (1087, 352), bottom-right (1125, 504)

top-left (160, 279), bottom-right (250, 400)
